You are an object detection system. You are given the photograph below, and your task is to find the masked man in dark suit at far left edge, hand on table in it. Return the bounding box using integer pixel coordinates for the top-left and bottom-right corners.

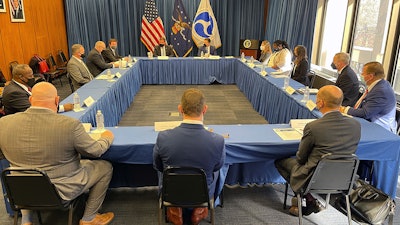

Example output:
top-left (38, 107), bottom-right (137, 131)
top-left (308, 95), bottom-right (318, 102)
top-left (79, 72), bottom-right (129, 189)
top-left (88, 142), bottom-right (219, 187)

top-left (3, 64), bottom-right (74, 115)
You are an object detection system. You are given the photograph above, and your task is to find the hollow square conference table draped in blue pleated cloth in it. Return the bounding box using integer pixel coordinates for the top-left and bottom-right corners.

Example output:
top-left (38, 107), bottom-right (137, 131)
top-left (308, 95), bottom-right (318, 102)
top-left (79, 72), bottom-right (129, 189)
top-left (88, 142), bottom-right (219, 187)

top-left (62, 58), bottom-right (400, 197)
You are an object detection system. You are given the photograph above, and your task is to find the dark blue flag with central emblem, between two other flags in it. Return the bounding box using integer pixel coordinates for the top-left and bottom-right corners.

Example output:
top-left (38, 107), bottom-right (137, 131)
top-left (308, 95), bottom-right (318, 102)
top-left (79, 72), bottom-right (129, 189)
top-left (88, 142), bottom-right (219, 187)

top-left (171, 0), bottom-right (193, 57)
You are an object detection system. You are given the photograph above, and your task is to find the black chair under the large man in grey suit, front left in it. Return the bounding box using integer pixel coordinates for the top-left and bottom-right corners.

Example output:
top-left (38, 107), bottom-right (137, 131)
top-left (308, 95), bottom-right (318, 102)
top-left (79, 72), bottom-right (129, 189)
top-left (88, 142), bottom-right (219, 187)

top-left (1, 167), bottom-right (80, 225)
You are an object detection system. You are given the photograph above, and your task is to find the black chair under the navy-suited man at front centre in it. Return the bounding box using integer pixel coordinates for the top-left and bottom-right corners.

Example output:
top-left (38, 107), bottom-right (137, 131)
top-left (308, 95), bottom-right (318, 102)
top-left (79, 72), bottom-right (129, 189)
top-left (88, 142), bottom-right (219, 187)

top-left (158, 167), bottom-right (215, 224)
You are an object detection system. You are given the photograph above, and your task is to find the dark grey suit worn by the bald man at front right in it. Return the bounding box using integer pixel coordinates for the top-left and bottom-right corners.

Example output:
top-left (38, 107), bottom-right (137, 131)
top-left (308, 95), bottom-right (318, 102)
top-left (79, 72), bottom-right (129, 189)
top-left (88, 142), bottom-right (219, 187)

top-left (276, 111), bottom-right (361, 192)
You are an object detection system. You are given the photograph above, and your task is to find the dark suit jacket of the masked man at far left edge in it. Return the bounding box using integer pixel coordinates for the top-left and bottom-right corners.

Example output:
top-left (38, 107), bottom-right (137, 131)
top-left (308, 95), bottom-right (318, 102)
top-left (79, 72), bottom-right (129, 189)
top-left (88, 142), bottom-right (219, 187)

top-left (3, 80), bottom-right (31, 115)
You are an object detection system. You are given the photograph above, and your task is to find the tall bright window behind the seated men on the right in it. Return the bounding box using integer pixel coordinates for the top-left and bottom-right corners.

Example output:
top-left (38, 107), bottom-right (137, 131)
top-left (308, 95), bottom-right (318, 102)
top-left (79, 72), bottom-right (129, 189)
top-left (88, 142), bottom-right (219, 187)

top-left (351, 0), bottom-right (392, 74)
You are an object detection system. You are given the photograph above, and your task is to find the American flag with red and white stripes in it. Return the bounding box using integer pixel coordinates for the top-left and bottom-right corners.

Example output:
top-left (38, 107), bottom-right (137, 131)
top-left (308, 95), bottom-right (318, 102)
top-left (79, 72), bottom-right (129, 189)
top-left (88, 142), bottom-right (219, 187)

top-left (140, 0), bottom-right (165, 52)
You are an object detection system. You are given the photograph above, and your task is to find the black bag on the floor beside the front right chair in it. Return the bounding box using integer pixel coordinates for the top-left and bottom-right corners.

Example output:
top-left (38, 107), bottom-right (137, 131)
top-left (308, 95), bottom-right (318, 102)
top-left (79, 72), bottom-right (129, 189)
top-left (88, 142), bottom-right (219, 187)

top-left (350, 180), bottom-right (396, 224)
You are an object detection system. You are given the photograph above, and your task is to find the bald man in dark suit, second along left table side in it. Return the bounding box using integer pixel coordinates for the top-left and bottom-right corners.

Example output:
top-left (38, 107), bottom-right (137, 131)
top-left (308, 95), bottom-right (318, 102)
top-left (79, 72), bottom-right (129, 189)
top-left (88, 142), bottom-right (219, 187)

top-left (86, 41), bottom-right (119, 76)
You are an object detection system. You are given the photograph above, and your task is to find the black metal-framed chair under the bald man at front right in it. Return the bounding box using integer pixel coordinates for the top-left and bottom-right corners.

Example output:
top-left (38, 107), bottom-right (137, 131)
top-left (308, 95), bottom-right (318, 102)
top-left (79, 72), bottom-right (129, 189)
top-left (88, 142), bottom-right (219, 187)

top-left (283, 153), bottom-right (359, 225)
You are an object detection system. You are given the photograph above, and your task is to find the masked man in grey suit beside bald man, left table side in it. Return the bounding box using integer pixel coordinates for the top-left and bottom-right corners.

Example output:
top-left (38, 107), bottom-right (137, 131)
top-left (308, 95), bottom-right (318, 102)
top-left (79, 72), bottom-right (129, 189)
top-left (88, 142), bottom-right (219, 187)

top-left (67, 44), bottom-right (93, 90)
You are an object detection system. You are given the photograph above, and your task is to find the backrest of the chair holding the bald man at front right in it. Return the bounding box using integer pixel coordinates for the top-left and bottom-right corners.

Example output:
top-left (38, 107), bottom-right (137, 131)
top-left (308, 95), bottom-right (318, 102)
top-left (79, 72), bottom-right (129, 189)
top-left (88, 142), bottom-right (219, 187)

top-left (304, 154), bottom-right (359, 195)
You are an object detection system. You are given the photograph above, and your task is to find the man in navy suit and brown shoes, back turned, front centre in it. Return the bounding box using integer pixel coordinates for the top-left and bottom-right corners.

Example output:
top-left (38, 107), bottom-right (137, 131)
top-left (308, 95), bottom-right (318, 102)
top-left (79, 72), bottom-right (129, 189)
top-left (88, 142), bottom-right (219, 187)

top-left (153, 88), bottom-right (225, 225)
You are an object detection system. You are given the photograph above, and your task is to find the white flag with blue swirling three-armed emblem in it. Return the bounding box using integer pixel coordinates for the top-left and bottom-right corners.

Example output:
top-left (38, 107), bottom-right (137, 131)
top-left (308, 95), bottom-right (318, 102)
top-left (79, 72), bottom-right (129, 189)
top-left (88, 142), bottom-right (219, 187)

top-left (192, 0), bottom-right (222, 48)
